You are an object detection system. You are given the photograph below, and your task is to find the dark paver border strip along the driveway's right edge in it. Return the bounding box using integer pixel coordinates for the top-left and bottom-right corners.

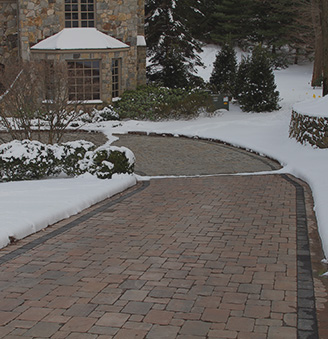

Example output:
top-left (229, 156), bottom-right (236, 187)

top-left (281, 174), bottom-right (319, 339)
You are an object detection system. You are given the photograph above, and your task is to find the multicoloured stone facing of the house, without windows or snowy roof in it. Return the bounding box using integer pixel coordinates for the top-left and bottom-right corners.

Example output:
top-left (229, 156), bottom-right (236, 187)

top-left (0, 0), bottom-right (146, 99)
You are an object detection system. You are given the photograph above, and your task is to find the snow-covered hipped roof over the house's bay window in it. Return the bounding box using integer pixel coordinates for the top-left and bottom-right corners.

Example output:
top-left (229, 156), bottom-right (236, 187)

top-left (31, 27), bottom-right (129, 50)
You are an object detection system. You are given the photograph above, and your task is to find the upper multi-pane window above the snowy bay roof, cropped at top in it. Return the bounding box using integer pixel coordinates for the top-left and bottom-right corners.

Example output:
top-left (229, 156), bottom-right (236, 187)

top-left (65, 0), bottom-right (95, 28)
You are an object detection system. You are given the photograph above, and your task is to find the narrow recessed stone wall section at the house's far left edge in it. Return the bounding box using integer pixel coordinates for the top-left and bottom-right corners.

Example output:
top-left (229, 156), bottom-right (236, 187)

top-left (0, 0), bottom-right (19, 64)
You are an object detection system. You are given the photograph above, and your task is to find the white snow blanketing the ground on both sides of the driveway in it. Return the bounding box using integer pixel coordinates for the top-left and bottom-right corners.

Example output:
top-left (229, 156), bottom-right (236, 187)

top-left (0, 48), bottom-right (328, 260)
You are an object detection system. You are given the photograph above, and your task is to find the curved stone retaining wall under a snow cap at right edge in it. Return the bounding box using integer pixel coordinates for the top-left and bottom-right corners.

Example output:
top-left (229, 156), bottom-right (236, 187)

top-left (289, 110), bottom-right (328, 148)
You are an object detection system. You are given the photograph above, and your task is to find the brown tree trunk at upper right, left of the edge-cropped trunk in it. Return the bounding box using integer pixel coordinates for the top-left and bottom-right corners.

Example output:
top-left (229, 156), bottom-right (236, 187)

top-left (311, 0), bottom-right (323, 87)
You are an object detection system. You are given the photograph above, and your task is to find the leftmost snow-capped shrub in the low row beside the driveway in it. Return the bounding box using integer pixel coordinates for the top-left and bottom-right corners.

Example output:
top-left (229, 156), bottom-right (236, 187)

top-left (0, 140), bottom-right (60, 181)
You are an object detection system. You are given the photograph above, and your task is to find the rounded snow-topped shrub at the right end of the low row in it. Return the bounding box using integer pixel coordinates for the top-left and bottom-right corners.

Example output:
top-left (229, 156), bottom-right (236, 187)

top-left (86, 144), bottom-right (134, 179)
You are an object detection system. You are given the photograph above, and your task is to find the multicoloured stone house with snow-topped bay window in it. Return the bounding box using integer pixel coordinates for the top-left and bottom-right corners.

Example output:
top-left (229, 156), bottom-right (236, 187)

top-left (0, 0), bottom-right (146, 103)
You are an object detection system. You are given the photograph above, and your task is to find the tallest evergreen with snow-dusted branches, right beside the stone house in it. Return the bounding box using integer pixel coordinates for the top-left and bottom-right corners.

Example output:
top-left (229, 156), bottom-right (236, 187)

top-left (145, 0), bottom-right (202, 87)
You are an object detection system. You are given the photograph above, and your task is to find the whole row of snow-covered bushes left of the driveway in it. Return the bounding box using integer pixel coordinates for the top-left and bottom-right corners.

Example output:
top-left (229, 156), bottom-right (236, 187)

top-left (0, 140), bottom-right (135, 181)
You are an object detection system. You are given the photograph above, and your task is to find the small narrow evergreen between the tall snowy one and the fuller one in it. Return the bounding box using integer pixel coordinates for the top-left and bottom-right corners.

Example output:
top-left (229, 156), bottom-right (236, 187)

top-left (210, 43), bottom-right (237, 96)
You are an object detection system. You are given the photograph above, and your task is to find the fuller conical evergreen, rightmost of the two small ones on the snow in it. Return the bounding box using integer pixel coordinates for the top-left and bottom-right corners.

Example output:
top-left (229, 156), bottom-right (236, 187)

top-left (237, 46), bottom-right (280, 112)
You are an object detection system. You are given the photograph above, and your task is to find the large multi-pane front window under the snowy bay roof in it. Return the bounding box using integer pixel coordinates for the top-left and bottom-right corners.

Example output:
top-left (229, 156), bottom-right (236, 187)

top-left (67, 60), bottom-right (100, 101)
